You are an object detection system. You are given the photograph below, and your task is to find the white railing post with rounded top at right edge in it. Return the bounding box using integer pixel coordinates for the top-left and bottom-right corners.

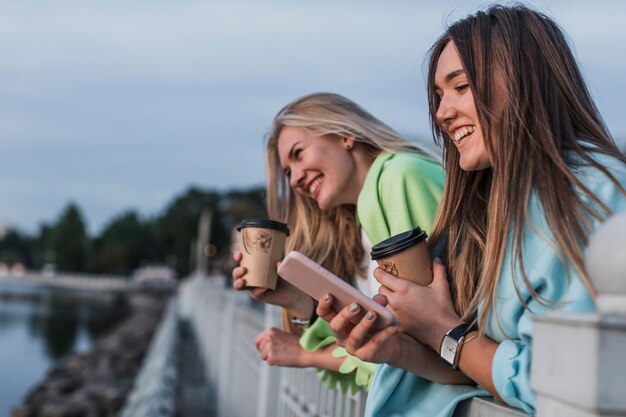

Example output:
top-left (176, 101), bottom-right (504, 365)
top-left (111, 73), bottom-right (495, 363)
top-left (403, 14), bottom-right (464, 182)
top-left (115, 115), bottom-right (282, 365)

top-left (532, 212), bottom-right (626, 417)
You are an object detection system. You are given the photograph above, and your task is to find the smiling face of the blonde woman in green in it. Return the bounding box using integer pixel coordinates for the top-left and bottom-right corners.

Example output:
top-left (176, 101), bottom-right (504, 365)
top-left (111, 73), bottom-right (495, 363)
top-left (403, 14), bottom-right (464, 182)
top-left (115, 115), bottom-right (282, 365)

top-left (278, 126), bottom-right (362, 210)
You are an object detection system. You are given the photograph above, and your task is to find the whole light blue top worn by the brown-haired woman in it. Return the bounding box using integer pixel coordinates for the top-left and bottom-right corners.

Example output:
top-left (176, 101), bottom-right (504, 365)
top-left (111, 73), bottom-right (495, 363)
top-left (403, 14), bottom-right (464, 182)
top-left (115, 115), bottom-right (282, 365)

top-left (365, 156), bottom-right (626, 417)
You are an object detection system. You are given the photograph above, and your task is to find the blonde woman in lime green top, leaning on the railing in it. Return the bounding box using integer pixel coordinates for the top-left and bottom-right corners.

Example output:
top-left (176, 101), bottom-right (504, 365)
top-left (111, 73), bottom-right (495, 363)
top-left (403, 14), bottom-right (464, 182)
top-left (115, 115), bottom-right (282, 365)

top-left (233, 93), bottom-right (444, 388)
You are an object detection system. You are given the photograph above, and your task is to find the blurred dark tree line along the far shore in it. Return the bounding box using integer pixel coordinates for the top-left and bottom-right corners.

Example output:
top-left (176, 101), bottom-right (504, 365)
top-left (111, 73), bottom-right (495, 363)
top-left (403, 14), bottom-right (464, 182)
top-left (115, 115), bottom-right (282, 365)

top-left (0, 187), bottom-right (266, 277)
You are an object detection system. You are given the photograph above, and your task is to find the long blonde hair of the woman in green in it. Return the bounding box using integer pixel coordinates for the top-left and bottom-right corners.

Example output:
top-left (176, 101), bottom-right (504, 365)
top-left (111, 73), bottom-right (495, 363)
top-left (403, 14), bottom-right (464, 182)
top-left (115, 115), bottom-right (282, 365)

top-left (266, 93), bottom-right (427, 279)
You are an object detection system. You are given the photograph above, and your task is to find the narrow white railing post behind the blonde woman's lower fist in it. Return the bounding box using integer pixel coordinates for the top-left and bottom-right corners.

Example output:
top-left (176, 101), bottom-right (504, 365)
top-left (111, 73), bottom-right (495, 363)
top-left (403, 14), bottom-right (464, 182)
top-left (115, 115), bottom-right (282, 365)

top-left (257, 304), bottom-right (281, 417)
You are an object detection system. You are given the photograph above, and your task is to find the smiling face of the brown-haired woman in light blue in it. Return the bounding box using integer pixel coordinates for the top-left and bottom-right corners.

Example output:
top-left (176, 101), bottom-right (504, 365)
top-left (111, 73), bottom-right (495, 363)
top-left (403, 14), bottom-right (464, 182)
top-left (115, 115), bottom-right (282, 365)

top-left (435, 42), bottom-right (491, 171)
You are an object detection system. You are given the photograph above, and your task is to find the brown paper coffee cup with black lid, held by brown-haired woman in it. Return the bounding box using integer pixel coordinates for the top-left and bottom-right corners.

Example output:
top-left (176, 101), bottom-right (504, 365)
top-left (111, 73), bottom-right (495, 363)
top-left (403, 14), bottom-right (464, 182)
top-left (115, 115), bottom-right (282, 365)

top-left (371, 227), bottom-right (433, 285)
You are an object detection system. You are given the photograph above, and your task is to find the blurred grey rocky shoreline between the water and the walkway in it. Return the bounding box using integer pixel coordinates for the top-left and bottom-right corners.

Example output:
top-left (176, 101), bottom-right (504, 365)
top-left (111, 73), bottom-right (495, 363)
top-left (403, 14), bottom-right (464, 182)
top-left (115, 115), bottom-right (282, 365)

top-left (11, 296), bottom-right (167, 417)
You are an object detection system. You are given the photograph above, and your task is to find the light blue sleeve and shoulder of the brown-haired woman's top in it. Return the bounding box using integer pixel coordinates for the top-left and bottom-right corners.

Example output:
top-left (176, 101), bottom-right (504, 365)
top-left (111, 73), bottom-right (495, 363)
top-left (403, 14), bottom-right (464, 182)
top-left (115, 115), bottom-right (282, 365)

top-left (488, 157), bottom-right (626, 413)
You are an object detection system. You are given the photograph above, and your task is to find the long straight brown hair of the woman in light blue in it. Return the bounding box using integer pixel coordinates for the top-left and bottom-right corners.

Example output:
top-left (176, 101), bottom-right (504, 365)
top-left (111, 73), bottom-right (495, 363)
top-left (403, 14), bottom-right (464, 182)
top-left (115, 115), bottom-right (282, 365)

top-left (428, 6), bottom-right (626, 329)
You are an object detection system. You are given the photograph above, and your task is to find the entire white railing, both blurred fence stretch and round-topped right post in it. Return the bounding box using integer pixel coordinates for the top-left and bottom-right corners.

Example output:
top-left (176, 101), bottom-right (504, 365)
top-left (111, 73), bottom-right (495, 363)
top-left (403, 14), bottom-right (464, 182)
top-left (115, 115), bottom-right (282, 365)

top-left (180, 213), bottom-right (626, 417)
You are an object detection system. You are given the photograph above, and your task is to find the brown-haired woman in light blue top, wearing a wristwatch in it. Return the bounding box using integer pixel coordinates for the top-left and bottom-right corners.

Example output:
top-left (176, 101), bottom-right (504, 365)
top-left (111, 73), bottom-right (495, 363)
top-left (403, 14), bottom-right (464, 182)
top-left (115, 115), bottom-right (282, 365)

top-left (318, 6), bottom-right (626, 417)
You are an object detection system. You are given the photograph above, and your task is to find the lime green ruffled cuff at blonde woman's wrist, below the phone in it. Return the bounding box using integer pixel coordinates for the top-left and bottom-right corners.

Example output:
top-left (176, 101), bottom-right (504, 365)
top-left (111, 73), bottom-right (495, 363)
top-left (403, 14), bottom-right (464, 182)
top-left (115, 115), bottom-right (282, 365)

top-left (300, 319), bottom-right (377, 394)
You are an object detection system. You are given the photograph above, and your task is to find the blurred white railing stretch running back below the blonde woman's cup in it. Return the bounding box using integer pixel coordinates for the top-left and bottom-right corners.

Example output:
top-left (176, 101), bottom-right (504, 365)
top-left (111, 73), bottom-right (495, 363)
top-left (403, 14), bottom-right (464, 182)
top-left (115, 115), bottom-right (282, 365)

top-left (179, 276), bottom-right (365, 417)
